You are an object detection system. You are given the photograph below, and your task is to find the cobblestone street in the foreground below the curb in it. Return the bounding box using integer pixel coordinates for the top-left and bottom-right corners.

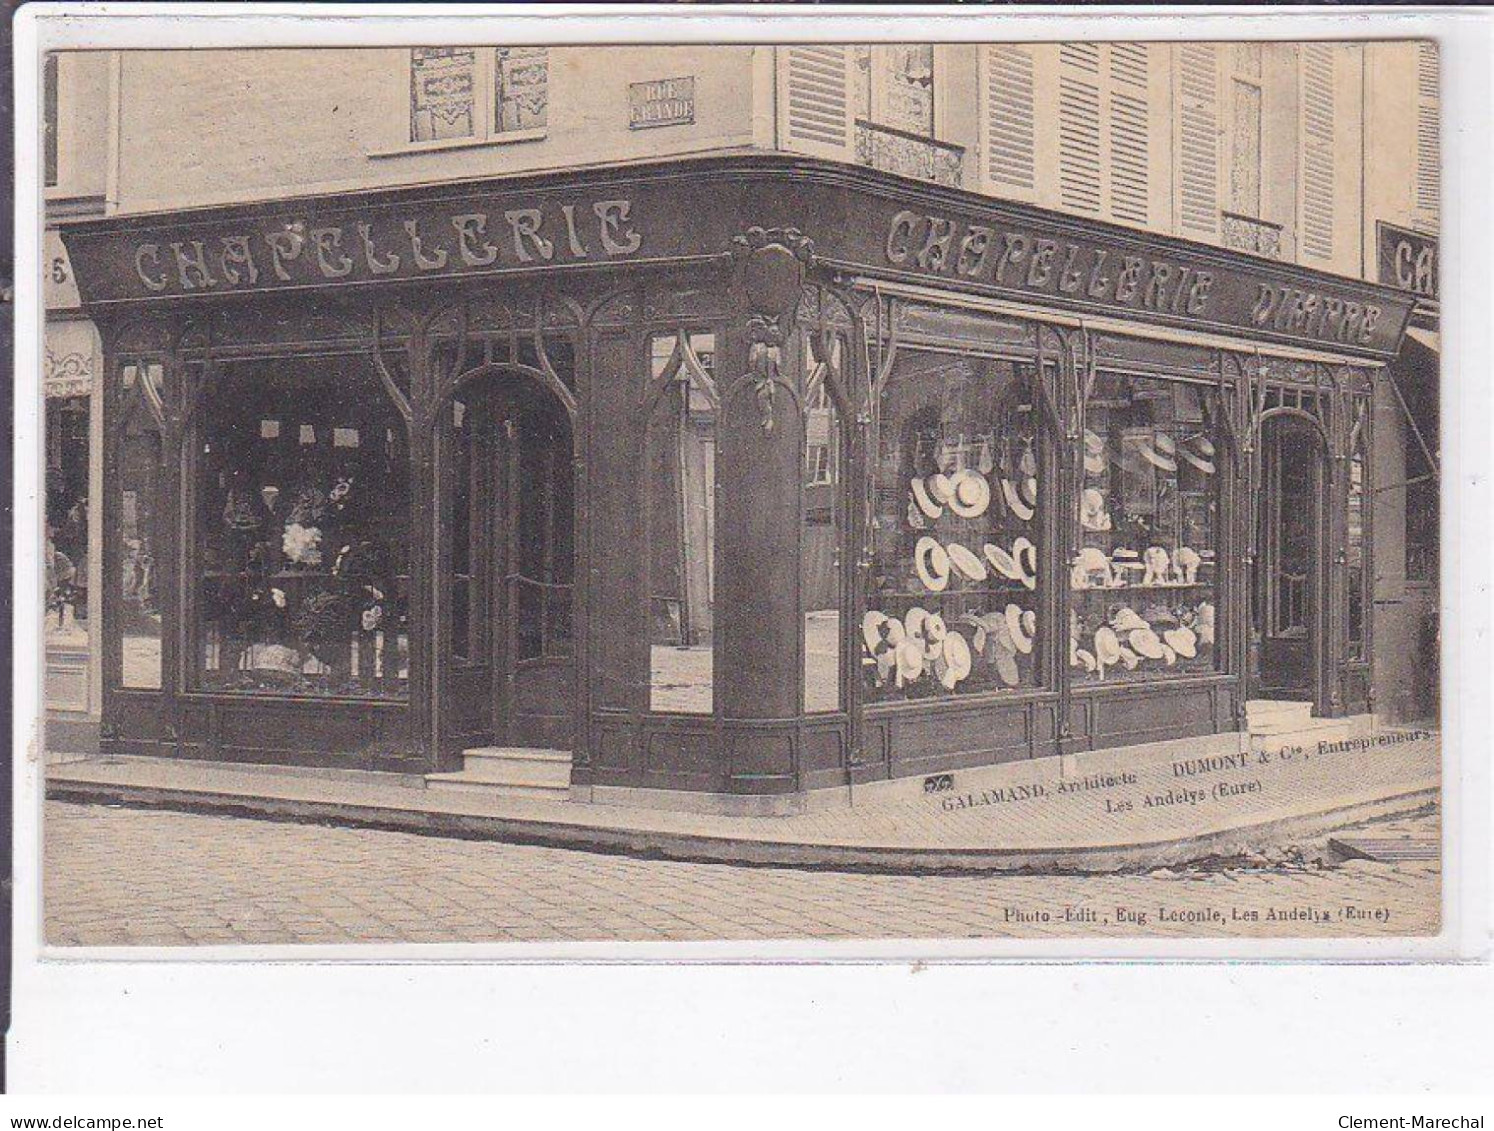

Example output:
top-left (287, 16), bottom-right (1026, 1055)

top-left (45, 802), bottom-right (1440, 946)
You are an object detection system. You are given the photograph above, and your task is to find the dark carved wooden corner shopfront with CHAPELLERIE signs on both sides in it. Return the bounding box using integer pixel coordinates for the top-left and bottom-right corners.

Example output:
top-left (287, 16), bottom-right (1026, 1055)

top-left (63, 155), bottom-right (1413, 801)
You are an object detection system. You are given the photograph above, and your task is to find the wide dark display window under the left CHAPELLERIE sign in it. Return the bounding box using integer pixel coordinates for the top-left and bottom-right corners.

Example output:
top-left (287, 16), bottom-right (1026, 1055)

top-left (194, 357), bottom-right (411, 699)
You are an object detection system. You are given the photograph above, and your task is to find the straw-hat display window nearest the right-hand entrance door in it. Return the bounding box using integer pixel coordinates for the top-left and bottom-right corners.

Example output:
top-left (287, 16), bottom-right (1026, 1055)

top-left (1068, 374), bottom-right (1219, 683)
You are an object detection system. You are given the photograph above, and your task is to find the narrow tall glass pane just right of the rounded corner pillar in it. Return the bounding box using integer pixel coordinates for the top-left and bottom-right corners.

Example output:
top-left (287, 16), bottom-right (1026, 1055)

top-left (799, 330), bottom-right (847, 714)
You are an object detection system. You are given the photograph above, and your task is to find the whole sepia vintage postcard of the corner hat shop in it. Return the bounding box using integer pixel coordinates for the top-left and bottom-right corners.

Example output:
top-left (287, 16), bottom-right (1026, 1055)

top-left (32, 22), bottom-right (1445, 956)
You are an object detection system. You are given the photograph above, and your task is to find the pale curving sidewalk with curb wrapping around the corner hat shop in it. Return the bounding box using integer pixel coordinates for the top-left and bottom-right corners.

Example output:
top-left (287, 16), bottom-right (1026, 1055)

top-left (46, 729), bottom-right (1440, 873)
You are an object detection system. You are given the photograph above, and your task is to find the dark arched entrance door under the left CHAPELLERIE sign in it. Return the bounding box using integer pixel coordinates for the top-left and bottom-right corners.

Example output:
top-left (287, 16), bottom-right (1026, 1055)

top-left (487, 385), bottom-right (575, 750)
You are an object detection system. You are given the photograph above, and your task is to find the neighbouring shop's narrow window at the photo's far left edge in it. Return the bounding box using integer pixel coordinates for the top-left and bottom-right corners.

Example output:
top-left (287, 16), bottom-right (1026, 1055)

top-left (45, 396), bottom-right (90, 647)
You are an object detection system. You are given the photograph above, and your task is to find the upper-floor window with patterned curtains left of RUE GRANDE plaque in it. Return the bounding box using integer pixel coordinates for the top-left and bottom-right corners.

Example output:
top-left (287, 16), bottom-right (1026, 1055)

top-left (409, 46), bottom-right (550, 142)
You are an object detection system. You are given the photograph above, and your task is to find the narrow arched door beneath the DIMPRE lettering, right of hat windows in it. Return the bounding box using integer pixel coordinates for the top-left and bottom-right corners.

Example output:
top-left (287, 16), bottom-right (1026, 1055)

top-left (1252, 415), bottom-right (1325, 702)
